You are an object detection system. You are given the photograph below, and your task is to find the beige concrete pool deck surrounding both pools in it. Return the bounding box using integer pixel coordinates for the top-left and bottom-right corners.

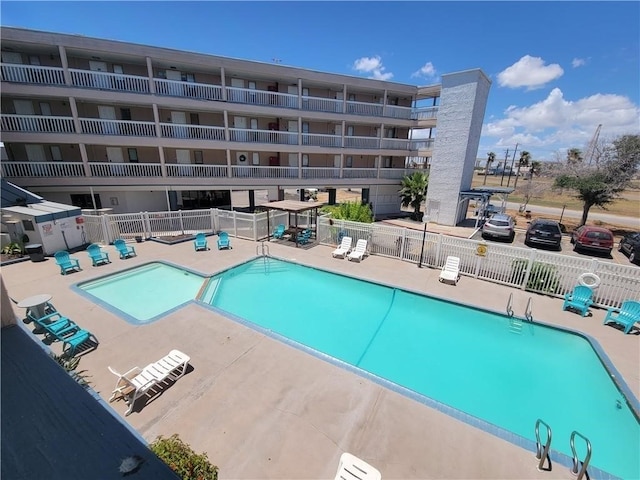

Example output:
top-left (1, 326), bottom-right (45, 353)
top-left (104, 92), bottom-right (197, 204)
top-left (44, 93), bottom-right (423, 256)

top-left (2, 237), bottom-right (640, 479)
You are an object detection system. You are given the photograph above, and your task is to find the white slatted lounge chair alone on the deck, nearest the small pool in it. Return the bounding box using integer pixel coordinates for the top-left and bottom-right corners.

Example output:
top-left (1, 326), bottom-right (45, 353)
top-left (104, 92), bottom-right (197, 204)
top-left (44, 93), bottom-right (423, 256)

top-left (107, 350), bottom-right (191, 416)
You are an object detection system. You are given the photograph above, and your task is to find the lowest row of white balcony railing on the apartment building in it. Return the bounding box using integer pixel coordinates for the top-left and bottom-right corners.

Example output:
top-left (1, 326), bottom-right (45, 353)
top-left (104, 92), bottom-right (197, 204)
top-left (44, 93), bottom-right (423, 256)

top-left (1, 161), bottom-right (411, 181)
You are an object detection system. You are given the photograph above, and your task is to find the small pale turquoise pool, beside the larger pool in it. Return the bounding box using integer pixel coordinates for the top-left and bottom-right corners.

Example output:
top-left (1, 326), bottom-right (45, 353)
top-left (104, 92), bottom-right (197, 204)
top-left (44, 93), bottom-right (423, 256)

top-left (78, 262), bottom-right (205, 324)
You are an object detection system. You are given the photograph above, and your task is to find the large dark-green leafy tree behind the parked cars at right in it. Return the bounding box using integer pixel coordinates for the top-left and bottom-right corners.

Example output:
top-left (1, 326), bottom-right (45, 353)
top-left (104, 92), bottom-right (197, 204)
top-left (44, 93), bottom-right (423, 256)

top-left (554, 135), bottom-right (640, 225)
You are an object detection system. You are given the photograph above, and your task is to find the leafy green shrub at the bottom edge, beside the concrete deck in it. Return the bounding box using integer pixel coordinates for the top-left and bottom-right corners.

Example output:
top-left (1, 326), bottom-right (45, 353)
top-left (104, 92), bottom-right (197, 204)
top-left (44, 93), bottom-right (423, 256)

top-left (150, 433), bottom-right (218, 480)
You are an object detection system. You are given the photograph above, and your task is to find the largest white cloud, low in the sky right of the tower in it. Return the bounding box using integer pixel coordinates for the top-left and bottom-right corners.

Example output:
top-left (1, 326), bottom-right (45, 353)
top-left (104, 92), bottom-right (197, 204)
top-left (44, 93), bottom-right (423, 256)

top-left (482, 88), bottom-right (640, 158)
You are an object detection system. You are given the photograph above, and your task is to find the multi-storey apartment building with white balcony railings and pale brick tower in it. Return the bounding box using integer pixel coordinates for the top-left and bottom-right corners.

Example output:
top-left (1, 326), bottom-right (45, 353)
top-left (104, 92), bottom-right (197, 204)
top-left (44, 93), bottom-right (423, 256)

top-left (1, 27), bottom-right (490, 224)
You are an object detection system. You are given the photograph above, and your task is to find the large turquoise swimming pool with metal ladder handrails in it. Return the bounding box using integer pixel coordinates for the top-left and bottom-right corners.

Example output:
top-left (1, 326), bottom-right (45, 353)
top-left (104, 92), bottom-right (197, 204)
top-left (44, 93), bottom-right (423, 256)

top-left (201, 259), bottom-right (640, 478)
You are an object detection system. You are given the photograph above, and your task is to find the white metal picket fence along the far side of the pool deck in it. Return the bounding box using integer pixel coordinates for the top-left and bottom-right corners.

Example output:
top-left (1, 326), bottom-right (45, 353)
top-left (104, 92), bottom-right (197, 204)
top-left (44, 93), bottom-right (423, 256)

top-left (84, 208), bottom-right (640, 307)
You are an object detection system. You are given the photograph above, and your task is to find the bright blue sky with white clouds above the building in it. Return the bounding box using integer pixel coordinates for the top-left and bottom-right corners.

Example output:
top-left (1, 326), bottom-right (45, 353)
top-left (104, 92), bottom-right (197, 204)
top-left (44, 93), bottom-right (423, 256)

top-left (0, 0), bottom-right (640, 161)
